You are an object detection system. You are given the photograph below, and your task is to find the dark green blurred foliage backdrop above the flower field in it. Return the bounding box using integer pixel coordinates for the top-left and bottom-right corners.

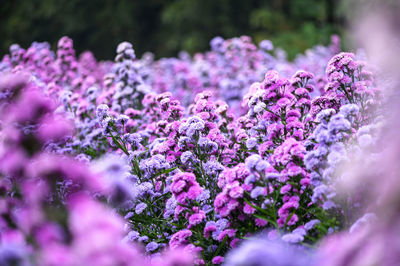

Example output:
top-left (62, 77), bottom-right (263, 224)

top-left (0, 0), bottom-right (346, 60)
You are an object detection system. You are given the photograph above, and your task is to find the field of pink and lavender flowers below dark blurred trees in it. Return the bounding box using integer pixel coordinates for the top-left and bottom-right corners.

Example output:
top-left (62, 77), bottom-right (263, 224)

top-left (0, 36), bottom-right (394, 266)
